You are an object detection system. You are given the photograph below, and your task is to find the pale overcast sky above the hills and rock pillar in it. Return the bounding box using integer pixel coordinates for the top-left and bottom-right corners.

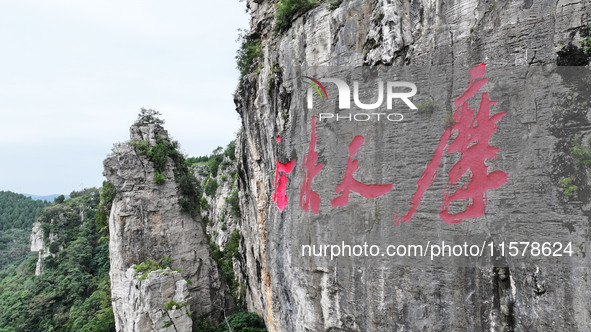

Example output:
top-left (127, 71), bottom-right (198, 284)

top-left (0, 0), bottom-right (249, 195)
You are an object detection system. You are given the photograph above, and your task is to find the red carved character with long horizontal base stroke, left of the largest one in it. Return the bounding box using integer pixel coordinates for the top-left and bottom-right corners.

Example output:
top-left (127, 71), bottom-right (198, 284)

top-left (330, 135), bottom-right (394, 207)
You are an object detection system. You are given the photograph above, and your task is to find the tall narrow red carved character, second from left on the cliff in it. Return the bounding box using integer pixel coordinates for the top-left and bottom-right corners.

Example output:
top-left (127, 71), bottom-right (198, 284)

top-left (300, 116), bottom-right (322, 214)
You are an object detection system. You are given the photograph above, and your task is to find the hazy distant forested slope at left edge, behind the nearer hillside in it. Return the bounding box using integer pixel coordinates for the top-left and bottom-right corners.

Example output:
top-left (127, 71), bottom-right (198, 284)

top-left (0, 191), bottom-right (49, 270)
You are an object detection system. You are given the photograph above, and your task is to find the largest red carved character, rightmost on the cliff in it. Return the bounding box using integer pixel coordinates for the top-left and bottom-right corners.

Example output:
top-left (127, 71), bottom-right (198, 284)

top-left (394, 64), bottom-right (508, 225)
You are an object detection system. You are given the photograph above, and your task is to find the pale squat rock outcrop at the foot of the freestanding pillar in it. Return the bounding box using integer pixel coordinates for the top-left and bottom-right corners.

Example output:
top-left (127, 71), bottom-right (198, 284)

top-left (118, 268), bottom-right (193, 332)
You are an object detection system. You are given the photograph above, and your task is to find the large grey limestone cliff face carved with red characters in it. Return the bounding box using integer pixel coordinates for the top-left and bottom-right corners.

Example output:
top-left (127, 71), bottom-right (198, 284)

top-left (235, 0), bottom-right (591, 331)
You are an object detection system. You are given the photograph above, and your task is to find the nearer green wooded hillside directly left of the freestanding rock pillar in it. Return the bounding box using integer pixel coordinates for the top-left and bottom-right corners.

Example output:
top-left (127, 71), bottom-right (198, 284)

top-left (0, 189), bottom-right (115, 332)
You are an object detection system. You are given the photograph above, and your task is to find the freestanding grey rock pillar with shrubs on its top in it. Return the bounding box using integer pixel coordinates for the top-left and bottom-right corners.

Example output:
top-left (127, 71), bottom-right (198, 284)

top-left (104, 123), bottom-right (232, 331)
